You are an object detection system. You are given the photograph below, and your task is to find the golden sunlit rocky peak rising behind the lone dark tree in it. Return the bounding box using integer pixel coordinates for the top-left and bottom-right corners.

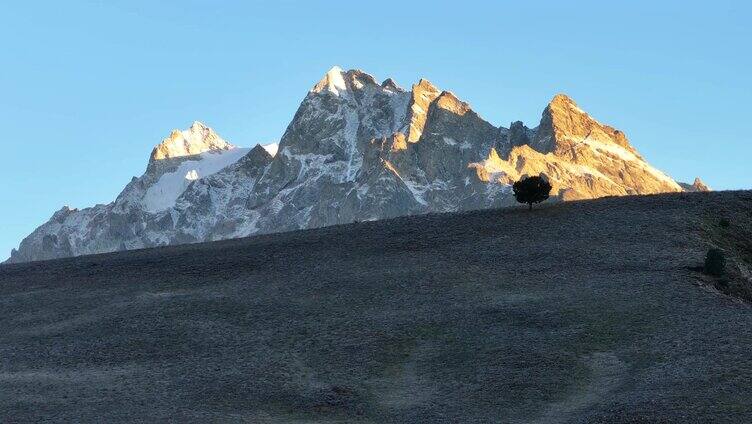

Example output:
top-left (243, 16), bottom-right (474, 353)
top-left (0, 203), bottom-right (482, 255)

top-left (471, 94), bottom-right (681, 200)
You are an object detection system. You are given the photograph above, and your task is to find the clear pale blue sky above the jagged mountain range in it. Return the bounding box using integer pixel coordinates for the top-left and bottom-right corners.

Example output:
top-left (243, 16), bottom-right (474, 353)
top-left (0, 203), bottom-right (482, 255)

top-left (0, 0), bottom-right (752, 259)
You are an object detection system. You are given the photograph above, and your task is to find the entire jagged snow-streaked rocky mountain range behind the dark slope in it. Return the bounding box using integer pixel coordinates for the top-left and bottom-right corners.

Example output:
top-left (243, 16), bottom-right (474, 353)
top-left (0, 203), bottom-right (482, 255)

top-left (10, 67), bottom-right (682, 262)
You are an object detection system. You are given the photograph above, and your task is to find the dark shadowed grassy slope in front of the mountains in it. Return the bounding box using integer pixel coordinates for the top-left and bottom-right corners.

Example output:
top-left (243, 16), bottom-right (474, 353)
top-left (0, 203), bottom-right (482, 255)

top-left (0, 192), bottom-right (752, 423)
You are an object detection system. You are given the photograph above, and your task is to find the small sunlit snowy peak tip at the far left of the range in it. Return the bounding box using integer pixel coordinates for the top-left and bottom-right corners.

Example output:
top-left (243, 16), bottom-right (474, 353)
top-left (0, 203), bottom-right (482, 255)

top-left (150, 121), bottom-right (235, 162)
